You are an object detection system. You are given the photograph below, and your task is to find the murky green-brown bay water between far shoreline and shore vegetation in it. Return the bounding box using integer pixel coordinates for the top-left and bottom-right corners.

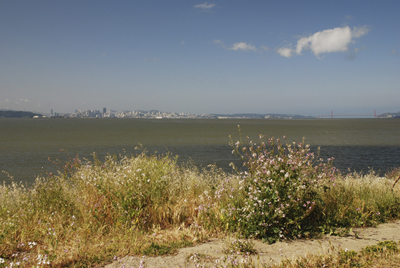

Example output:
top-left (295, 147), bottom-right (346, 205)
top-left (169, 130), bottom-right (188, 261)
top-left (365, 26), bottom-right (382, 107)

top-left (0, 118), bottom-right (400, 183)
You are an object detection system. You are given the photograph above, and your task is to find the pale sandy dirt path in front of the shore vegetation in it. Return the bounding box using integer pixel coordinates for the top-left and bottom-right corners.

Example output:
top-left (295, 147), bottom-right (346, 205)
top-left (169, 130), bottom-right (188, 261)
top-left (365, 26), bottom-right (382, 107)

top-left (105, 220), bottom-right (400, 268)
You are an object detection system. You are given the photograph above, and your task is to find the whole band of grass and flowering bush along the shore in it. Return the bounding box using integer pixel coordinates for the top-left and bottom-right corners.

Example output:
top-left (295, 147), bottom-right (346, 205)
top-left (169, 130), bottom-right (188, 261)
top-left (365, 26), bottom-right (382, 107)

top-left (0, 131), bottom-right (400, 267)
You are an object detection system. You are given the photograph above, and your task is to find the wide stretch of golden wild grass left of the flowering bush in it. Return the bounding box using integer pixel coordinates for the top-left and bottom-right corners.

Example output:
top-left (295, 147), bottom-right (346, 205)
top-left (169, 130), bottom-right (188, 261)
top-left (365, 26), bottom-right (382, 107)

top-left (0, 154), bottom-right (219, 267)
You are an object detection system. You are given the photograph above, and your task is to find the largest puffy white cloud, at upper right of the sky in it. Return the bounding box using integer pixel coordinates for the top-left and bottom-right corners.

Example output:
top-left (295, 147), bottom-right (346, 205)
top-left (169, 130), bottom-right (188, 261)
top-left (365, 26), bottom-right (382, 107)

top-left (278, 26), bottom-right (369, 57)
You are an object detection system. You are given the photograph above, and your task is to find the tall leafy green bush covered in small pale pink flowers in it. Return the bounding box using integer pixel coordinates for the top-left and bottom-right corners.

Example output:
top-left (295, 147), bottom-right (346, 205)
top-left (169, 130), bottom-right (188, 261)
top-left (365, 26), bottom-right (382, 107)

top-left (209, 132), bottom-right (335, 243)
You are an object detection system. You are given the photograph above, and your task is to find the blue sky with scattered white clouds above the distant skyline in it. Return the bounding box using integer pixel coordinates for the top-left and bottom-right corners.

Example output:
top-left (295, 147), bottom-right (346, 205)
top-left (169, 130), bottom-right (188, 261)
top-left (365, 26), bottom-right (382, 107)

top-left (0, 0), bottom-right (400, 116)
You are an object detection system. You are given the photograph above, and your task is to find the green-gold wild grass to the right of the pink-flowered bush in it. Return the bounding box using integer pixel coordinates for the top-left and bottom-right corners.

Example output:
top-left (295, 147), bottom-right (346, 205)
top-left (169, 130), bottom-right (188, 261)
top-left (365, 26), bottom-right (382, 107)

top-left (321, 172), bottom-right (400, 233)
